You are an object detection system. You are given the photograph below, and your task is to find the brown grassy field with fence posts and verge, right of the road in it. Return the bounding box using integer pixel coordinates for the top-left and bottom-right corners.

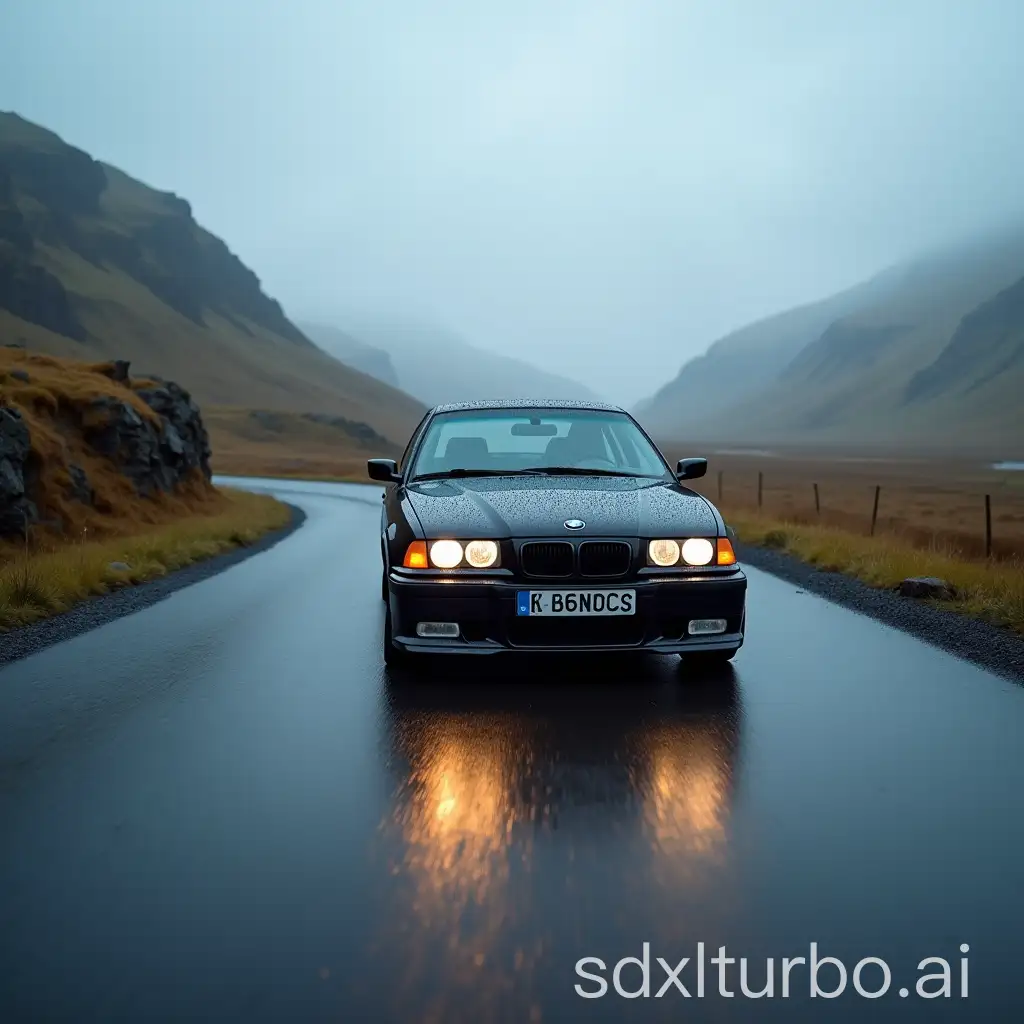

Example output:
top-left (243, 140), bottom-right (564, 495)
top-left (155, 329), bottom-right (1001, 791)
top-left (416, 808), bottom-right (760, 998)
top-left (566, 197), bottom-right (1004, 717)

top-left (673, 451), bottom-right (1024, 634)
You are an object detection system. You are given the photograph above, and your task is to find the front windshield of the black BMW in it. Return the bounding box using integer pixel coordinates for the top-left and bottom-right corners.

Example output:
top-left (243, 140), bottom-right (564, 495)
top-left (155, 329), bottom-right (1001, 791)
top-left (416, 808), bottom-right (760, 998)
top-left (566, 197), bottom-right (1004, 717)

top-left (411, 409), bottom-right (672, 479)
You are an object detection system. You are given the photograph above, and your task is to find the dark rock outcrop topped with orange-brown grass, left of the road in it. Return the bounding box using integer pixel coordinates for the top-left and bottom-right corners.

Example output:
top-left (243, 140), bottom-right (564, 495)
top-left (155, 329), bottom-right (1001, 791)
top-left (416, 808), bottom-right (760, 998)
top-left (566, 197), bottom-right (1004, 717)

top-left (0, 348), bottom-right (213, 538)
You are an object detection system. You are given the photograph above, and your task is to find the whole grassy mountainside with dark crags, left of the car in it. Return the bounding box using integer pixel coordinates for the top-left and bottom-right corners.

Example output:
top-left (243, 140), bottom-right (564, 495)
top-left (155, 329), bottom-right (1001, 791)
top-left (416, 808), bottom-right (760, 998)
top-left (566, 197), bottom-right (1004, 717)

top-left (0, 114), bottom-right (422, 448)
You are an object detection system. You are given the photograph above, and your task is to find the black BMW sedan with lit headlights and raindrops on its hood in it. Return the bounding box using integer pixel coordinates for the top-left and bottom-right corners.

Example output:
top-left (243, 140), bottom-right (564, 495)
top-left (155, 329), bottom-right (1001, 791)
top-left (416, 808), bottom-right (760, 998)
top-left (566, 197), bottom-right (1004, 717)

top-left (369, 400), bottom-right (746, 666)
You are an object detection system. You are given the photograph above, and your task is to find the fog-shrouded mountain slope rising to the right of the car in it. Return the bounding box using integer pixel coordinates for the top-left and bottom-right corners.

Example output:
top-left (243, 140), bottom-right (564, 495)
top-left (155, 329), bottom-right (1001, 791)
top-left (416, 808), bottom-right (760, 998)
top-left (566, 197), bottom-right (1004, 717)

top-left (637, 227), bottom-right (1024, 447)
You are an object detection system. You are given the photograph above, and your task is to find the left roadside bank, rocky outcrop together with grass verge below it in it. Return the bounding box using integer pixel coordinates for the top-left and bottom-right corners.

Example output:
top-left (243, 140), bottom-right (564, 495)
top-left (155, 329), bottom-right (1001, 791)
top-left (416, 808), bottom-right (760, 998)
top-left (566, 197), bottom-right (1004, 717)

top-left (0, 347), bottom-right (291, 631)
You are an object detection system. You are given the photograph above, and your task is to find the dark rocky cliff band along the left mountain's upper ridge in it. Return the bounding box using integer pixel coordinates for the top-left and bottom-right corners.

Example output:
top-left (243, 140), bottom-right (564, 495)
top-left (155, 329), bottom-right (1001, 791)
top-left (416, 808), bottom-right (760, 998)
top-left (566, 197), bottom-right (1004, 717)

top-left (0, 115), bottom-right (299, 346)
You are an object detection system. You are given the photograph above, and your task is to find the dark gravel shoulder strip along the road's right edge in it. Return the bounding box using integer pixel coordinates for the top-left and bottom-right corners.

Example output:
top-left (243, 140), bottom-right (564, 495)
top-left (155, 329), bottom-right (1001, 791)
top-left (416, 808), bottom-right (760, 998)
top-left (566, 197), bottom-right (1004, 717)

top-left (736, 542), bottom-right (1024, 683)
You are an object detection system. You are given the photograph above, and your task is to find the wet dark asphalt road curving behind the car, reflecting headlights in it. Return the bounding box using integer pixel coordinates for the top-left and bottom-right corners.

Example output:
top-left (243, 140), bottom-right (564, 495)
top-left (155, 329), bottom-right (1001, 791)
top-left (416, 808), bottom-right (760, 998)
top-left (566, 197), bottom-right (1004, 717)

top-left (0, 483), bottom-right (1024, 1024)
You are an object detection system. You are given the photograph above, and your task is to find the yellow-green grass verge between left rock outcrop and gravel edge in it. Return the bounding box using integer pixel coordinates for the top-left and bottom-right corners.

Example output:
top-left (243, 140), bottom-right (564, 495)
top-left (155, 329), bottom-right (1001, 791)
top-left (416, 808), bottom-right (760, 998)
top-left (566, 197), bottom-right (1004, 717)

top-left (0, 488), bottom-right (290, 631)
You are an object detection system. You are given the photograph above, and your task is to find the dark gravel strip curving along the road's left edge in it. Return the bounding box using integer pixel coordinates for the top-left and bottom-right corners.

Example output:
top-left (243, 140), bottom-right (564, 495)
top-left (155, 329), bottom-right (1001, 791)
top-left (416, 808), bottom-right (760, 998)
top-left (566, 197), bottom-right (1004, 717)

top-left (0, 503), bottom-right (306, 666)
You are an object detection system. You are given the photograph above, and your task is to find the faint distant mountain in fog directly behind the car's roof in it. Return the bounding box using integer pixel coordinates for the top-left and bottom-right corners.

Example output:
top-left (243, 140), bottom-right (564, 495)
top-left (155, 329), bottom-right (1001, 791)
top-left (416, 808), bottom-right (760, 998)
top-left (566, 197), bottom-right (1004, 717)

top-left (306, 313), bottom-right (597, 406)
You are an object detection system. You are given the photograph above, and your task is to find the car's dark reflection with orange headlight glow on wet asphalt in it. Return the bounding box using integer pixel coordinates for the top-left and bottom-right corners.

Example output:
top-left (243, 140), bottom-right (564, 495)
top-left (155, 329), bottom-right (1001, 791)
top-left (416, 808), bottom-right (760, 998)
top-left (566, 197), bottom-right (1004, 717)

top-left (368, 660), bottom-right (740, 1020)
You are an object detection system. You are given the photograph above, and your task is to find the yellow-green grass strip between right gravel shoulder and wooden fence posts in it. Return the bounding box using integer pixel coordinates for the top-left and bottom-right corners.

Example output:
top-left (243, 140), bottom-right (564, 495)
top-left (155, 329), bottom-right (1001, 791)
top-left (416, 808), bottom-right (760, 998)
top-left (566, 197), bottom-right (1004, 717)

top-left (723, 509), bottom-right (1024, 633)
